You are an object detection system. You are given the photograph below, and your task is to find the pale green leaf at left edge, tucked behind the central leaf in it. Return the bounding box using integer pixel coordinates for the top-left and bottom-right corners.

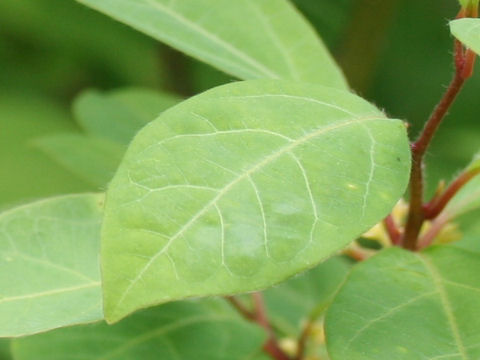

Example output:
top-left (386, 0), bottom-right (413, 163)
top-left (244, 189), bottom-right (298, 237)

top-left (0, 194), bottom-right (103, 337)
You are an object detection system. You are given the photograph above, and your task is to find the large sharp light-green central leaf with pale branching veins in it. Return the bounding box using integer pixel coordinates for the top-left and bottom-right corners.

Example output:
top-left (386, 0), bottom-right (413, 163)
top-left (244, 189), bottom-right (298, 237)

top-left (102, 80), bottom-right (410, 322)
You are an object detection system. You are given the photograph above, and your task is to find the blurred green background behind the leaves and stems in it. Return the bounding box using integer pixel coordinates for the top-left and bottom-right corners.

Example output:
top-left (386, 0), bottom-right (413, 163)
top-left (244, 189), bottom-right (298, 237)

top-left (0, 0), bottom-right (480, 208)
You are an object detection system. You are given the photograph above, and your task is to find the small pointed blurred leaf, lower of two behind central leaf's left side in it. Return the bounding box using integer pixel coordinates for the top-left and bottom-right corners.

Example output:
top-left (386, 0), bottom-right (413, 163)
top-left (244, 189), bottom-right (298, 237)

top-left (35, 134), bottom-right (125, 188)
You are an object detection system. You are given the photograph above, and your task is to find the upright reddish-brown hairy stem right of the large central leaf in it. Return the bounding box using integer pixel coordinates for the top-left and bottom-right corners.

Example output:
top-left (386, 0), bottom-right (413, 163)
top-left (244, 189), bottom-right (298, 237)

top-left (402, 41), bottom-right (473, 250)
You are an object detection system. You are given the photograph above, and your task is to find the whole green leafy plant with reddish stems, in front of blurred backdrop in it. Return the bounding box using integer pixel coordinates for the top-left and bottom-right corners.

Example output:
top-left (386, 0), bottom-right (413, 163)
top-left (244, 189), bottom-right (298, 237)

top-left (0, 0), bottom-right (480, 360)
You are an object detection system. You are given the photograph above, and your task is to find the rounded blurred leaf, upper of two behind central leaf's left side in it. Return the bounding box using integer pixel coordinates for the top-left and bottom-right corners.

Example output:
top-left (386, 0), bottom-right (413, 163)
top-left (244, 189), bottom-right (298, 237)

top-left (73, 88), bottom-right (180, 144)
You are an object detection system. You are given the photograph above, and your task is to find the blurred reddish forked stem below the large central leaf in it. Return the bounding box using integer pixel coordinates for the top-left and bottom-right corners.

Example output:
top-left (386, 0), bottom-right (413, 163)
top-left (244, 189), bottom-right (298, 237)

top-left (225, 293), bottom-right (290, 360)
